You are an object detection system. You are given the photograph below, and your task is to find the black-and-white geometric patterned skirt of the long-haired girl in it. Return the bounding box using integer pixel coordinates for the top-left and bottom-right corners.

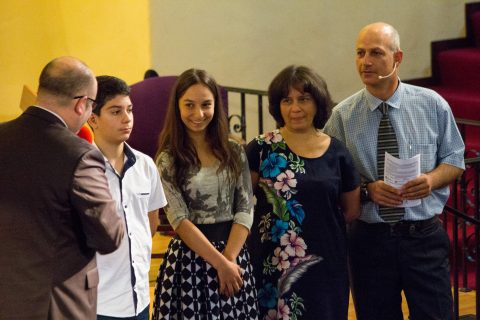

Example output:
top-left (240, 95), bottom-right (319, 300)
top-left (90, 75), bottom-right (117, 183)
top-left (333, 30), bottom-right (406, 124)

top-left (152, 222), bottom-right (258, 320)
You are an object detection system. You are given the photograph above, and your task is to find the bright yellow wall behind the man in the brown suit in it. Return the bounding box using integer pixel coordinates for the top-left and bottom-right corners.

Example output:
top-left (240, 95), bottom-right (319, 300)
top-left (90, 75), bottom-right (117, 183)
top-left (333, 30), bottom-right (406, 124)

top-left (0, 0), bottom-right (151, 122)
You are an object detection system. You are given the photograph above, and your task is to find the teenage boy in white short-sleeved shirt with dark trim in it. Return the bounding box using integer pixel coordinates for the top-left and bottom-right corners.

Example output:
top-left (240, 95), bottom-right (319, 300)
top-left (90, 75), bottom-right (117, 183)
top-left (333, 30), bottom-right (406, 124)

top-left (88, 76), bottom-right (167, 320)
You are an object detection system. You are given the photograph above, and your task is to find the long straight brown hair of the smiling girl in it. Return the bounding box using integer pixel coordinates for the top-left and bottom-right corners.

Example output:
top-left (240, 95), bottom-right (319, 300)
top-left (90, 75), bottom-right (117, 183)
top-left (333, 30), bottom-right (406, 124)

top-left (156, 69), bottom-right (241, 189)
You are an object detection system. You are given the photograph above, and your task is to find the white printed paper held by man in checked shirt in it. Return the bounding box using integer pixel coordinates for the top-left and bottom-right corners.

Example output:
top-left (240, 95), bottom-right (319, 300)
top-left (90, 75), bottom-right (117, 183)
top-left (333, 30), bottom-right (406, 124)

top-left (384, 152), bottom-right (422, 207)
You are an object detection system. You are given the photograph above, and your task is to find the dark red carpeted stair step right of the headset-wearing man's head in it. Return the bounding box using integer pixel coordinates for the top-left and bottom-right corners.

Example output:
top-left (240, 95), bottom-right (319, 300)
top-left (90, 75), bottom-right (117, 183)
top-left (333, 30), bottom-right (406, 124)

top-left (438, 48), bottom-right (480, 91)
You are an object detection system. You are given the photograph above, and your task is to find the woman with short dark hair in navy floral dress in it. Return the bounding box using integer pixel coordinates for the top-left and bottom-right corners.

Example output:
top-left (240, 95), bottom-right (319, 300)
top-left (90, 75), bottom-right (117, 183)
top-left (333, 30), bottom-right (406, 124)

top-left (247, 66), bottom-right (360, 320)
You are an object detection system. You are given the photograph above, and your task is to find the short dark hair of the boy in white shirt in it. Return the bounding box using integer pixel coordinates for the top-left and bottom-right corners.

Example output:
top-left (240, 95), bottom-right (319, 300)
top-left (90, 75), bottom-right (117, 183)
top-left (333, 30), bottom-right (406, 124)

top-left (92, 76), bottom-right (130, 115)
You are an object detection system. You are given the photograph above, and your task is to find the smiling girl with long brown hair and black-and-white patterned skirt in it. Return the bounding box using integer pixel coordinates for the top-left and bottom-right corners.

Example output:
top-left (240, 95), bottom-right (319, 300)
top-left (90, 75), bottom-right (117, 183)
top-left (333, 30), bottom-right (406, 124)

top-left (153, 69), bottom-right (257, 320)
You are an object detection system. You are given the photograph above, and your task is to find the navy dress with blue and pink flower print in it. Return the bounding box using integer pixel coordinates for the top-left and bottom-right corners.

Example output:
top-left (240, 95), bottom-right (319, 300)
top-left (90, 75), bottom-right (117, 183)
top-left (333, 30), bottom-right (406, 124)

top-left (247, 130), bottom-right (360, 320)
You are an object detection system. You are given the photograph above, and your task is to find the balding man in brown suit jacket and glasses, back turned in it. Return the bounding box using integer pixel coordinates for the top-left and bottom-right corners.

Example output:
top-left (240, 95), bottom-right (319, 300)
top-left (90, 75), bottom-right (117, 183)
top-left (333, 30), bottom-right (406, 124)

top-left (0, 57), bottom-right (124, 320)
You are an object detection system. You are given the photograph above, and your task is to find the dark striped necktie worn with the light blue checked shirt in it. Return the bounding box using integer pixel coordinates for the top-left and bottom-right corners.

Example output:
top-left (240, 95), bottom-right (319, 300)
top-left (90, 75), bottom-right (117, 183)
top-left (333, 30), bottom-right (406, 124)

top-left (377, 102), bottom-right (405, 224)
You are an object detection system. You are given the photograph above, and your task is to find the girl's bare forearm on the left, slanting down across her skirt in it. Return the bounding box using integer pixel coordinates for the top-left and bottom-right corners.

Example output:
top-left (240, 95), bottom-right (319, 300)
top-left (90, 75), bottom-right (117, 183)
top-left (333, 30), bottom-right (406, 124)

top-left (175, 219), bottom-right (230, 269)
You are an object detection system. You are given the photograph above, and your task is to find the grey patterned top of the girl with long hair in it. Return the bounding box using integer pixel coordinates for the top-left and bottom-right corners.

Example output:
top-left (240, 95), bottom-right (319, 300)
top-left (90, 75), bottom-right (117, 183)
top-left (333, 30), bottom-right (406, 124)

top-left (156, 141), bottom-right (253, 230)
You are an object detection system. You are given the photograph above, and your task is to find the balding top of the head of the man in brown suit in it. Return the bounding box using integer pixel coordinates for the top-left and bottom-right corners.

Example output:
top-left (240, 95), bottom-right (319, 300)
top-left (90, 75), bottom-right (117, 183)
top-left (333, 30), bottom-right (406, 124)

top-left (38, 57), bottom-right (95, 104)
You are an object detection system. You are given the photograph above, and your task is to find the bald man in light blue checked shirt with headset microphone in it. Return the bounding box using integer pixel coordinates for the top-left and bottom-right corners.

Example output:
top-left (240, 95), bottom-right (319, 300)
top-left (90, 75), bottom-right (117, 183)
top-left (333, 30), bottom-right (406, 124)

top-left (324, 22), bottom-right (465, 320)
